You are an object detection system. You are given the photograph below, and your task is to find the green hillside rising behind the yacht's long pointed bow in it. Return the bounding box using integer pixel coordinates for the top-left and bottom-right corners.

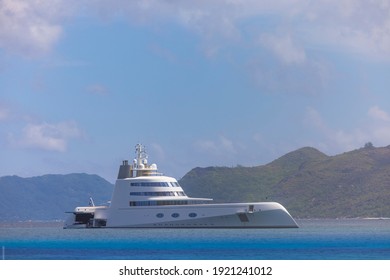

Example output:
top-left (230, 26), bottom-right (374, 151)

top-left (180, 145), bottom-right (390, 218)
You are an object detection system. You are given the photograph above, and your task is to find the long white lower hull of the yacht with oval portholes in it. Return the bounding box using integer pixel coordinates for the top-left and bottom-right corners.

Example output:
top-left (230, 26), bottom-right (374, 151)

top-left (65, 202), bottom-right (298, 228)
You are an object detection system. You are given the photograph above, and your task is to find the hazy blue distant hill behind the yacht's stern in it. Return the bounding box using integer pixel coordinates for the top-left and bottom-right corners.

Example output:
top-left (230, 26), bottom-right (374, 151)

top-left (0, 174), bottom-right (113, 221)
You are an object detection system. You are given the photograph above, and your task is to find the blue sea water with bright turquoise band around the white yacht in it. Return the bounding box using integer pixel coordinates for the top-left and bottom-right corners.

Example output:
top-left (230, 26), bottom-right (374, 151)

top-left (0, 219), bottom-right (390, 260)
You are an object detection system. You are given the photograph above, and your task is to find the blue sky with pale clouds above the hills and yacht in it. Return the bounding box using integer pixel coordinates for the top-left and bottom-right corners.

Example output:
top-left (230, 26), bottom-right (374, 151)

top-left (0, 0), bottom-right (390, 182)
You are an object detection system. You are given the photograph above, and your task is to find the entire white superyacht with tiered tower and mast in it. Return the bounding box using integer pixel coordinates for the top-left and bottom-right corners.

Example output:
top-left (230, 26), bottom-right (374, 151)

top-left (64, 144), bottom-right (298, 228)
